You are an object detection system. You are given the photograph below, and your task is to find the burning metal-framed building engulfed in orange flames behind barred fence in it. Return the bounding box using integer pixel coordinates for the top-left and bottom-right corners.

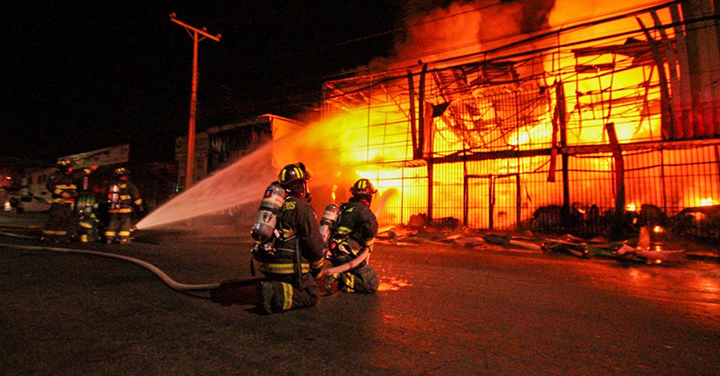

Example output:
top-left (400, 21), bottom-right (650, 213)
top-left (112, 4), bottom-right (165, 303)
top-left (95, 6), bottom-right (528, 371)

top-left (322, 0), bottom-right (720, 235)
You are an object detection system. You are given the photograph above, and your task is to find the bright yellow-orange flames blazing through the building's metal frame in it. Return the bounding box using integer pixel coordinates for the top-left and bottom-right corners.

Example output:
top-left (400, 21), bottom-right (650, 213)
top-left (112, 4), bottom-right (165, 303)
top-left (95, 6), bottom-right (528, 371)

top-left (320, 0), bottom-right (716, 228)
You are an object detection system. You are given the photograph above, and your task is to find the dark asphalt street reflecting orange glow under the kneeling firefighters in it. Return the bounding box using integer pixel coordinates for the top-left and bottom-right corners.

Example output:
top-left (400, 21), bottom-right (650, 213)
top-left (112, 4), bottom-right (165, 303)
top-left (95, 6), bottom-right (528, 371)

top-left (0, 213), bottom-right (720, 375)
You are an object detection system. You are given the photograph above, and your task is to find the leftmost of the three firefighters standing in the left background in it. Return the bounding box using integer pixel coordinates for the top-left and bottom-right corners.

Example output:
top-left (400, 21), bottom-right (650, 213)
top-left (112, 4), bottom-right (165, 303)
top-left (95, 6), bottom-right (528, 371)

top-left (42, 159), bottom-right (78, 243)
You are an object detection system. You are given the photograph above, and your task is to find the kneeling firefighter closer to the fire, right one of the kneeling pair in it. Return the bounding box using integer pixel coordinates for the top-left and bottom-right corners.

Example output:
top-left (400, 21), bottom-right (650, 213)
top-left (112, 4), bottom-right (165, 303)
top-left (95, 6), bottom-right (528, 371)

top-left (325, 179), bottom-right (380, 293)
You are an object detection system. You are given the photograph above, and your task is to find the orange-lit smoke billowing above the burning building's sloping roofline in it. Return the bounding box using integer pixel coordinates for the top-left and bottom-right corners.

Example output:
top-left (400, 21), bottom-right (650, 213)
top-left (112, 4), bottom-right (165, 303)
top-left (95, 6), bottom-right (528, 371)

top-left (385, 0), bottom-right (662, 67)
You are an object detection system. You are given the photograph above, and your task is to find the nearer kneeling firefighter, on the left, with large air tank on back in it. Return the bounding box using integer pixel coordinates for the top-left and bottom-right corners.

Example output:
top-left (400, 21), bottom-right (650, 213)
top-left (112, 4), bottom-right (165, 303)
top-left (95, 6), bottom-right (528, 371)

top-left (253, 163), bottom-right (324, 314)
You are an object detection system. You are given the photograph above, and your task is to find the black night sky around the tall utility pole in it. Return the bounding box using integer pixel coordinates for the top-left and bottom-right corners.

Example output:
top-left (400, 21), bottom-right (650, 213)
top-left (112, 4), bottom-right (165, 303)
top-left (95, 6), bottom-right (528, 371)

top-left (0, 0), bottom-right (414, 161)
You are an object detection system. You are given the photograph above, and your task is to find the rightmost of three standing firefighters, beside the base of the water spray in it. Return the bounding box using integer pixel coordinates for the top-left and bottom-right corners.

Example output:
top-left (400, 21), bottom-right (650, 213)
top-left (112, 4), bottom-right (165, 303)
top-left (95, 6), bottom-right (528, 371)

top-left (105, 167), bottom-right (142, 244)
